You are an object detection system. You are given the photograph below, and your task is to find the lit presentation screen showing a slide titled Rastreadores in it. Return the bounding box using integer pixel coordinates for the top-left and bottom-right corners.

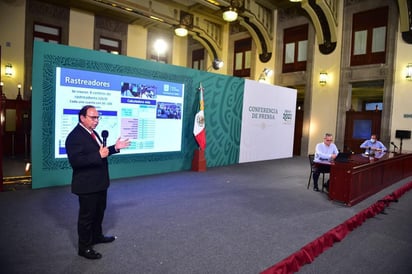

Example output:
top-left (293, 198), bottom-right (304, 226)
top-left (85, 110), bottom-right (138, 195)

top-left (54, 67), bottom-right (184, 158)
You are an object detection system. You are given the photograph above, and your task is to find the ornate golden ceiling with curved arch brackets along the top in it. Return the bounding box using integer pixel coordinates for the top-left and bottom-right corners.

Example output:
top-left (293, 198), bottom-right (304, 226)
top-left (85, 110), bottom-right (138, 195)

top-left (38, 0), bottom-right (412, 63)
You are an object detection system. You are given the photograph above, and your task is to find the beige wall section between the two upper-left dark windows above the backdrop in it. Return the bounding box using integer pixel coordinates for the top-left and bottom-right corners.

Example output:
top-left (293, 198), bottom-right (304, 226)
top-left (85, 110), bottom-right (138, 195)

top-left (69, 9), bottom-right (94, 49)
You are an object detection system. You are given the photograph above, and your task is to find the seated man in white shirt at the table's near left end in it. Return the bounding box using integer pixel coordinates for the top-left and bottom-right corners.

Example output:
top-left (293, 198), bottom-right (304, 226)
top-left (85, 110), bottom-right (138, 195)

top-left (313, 133), bottom-right (339, 191)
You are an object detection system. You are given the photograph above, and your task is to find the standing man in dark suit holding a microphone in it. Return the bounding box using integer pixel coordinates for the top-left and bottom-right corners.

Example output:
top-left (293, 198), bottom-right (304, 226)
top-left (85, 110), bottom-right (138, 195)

top-left (66, 105), bottom-right (130, 259)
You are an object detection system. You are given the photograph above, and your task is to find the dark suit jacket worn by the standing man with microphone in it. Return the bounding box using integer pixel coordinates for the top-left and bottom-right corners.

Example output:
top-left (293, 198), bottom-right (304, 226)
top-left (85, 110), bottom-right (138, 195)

top-left (66, 124), bottom-right (117, 194)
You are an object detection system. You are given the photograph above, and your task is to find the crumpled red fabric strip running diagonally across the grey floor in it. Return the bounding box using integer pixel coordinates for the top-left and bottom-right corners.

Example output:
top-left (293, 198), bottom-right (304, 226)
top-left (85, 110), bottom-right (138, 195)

top-left (261, 182), bottom-right (412, 274)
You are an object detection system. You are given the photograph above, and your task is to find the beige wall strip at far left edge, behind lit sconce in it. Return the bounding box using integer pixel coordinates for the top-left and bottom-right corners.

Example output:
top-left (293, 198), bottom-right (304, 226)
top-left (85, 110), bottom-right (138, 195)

top-left (0, 1), bottom-right (26, 99)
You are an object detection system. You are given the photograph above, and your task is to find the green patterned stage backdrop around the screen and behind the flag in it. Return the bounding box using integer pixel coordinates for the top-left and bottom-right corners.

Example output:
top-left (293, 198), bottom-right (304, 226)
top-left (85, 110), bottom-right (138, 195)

top-left (32, 42), bottom-right (245, 188)
